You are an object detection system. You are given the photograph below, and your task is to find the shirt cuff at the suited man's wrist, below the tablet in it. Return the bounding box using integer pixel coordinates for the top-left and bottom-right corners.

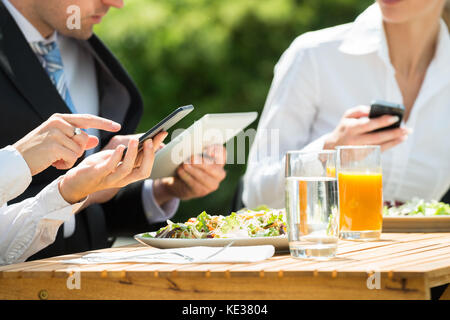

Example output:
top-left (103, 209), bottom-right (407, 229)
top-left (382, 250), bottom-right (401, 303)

top-left (142, 179), bottom-right (180, 224)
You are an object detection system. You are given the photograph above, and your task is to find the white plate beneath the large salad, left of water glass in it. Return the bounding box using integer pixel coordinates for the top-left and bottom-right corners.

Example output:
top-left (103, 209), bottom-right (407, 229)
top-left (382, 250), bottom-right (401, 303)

top-left (134, 232), bottom-right (289, 251)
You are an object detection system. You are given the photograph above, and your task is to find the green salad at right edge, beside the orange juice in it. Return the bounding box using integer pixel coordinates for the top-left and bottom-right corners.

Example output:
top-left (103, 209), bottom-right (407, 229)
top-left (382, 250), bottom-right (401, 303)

top-left (383, 198), bottom-right (450, 217)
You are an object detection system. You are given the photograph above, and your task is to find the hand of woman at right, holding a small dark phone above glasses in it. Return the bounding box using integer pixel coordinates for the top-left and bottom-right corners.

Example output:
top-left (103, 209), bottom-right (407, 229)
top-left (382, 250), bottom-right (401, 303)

top-left (324, 106), bottom-right (411, 151)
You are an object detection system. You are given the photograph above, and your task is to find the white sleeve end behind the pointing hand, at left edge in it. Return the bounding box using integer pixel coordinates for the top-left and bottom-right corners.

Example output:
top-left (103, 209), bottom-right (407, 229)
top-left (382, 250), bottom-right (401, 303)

top-left (0, 146), bottom-right (31, 206)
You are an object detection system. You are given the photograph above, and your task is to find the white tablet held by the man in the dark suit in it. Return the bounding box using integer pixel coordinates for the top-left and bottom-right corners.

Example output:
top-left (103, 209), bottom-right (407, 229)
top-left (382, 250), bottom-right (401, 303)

top-left (150, 112), bottom-right (258, 179)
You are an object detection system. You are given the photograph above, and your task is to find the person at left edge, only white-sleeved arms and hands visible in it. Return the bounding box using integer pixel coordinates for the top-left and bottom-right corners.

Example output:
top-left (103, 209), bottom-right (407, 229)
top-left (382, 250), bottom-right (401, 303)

top-left (0, 114), bottom-right (166, 265)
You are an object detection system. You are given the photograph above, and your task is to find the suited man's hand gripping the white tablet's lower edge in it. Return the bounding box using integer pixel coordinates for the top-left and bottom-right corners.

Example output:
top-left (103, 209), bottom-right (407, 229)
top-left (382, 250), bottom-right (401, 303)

top-left (153, 145), bottom-right (226, 205)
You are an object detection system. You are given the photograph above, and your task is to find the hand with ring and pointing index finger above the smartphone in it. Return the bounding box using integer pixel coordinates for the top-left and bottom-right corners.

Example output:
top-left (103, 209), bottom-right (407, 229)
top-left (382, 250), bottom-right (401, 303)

top-left (14, 114), bottom-right (120, 175)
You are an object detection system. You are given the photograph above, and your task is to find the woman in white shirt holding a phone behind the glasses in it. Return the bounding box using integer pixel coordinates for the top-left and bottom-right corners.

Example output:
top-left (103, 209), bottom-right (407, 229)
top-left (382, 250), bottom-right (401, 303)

top-left (243, 0), bottom-right (450, 208)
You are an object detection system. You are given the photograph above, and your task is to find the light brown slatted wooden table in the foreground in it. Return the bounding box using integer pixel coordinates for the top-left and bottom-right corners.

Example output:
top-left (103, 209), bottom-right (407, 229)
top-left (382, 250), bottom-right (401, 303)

top-left (0, 233), bottom-right (450, 300)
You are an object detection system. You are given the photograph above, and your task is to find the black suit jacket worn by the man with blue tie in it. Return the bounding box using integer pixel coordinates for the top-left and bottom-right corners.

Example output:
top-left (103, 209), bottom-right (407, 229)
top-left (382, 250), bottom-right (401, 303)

top-left (0, 2), bottom-right (161, 259)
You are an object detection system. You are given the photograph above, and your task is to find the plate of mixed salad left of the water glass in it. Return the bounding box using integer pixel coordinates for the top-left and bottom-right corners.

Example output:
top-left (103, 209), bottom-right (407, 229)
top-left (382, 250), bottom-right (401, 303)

top-left (134, 206), bottom-right (289, 251)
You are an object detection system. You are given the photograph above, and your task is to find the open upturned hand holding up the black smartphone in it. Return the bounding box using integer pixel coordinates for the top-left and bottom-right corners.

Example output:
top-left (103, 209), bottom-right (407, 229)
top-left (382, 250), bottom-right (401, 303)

top-left (59, 134), bottom-right (166, 203)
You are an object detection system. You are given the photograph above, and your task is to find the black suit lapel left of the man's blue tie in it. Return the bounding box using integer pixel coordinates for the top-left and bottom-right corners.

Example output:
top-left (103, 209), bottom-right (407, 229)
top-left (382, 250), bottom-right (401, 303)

top-left (0, 2), bottom-right (70, 120)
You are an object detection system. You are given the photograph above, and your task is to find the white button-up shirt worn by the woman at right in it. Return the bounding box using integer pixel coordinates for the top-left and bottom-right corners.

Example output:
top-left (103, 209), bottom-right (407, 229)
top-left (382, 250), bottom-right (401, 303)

top-left (243, 4), bottom-right (450, 208)
